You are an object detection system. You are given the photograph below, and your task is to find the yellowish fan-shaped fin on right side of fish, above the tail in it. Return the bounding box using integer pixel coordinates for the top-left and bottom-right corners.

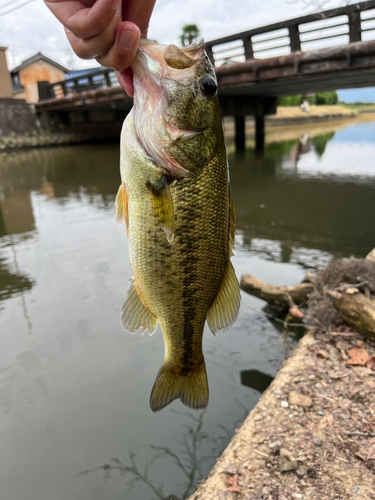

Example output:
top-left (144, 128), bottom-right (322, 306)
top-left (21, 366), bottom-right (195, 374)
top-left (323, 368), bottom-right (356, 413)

top-left (207, 262), bottom-right (241, 335)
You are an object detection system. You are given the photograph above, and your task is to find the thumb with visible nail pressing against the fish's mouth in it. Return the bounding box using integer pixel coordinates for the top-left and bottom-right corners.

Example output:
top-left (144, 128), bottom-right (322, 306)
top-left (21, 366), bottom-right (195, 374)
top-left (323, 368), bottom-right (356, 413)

top-left (96, 23), bottom-right (141, 72)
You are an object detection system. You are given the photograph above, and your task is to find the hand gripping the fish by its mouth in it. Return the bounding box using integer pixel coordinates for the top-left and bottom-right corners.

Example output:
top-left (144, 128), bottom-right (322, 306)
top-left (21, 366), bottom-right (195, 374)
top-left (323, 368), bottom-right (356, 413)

top-left (44, 0), bottom-right (156, 95)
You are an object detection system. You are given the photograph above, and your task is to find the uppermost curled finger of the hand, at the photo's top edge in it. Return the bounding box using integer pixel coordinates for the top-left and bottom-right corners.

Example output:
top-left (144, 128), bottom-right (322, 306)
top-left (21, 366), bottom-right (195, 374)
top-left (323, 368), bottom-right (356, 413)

top-left (46, 0), bottom-right (121, 39)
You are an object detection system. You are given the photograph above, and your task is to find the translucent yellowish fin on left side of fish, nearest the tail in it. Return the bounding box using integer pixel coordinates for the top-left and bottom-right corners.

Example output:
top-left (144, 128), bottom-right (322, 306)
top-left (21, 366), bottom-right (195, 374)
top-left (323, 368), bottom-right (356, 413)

top-left (121, 283), bottom-right (158, 335)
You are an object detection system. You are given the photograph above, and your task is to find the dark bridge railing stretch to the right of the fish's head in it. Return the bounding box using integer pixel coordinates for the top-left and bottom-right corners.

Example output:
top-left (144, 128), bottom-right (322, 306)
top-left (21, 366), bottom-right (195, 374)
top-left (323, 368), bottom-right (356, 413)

top-left (206, 0), bottom-right (375, 66)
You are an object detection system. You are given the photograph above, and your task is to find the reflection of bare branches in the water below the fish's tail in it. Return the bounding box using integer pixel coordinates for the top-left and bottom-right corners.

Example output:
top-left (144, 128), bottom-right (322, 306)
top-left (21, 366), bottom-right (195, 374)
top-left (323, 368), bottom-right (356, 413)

top-left (78, 408), bottom-right (250, 500)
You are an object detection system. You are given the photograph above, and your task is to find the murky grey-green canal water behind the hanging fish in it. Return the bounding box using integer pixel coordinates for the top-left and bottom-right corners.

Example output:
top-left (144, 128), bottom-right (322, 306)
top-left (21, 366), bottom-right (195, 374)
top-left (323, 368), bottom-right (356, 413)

top-left (0, 117), bottom-right (375, 500)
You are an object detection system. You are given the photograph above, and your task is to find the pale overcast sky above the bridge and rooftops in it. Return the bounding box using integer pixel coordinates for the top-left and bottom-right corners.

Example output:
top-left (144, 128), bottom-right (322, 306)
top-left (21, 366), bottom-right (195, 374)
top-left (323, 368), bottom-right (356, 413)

top-left (0, 0), bottom-right (364, 69)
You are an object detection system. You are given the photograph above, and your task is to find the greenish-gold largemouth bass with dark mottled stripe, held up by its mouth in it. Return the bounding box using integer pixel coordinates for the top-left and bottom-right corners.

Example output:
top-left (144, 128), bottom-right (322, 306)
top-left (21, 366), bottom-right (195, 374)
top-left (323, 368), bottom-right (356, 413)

top-left (116, 39), bottom-right (240, 412)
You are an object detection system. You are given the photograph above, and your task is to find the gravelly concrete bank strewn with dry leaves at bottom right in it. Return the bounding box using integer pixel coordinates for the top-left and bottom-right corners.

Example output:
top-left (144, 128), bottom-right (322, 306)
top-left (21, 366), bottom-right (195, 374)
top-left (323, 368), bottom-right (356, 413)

top-left (189, 327), bottom-right (375, 500)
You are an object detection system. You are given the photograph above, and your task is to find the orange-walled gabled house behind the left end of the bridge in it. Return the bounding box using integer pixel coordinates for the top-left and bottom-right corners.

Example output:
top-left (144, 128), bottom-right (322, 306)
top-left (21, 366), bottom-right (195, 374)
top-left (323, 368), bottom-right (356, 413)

top-left (11, 52), bottom-right (69, 103)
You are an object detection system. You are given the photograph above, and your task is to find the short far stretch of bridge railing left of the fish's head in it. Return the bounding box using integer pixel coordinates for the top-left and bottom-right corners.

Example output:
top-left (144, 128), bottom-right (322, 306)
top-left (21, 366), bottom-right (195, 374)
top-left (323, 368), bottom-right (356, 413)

top-left (38, 68), bottom-right (119, 101)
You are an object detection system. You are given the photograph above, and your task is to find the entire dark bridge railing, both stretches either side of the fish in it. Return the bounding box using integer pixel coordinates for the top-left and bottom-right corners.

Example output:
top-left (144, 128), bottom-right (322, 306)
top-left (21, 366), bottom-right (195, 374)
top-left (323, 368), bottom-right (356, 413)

top-left (38, 0), bottom-right (375, 101)
